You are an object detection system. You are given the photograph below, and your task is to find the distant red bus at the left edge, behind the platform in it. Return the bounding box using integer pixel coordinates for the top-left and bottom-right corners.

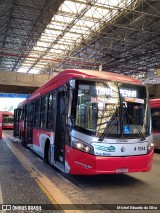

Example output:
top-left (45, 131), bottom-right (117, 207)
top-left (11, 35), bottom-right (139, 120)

top-left (0, 111), bottom-right (14, 129)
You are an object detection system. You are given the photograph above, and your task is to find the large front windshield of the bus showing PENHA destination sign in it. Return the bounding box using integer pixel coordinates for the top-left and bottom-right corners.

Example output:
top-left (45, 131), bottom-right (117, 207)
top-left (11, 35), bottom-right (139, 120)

top-left (75, 80), bottom-right (150, 139)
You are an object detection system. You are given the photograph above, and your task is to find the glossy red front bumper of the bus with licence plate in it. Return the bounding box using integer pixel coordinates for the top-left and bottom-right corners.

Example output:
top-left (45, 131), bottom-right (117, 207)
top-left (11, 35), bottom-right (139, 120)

top-left (66, 146), bottom-right (154, 175)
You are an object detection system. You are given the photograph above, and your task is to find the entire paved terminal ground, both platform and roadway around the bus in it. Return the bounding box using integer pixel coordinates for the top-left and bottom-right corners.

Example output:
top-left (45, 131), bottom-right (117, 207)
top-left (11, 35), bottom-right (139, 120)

top-left (0, 131), bottom-right (160, 213)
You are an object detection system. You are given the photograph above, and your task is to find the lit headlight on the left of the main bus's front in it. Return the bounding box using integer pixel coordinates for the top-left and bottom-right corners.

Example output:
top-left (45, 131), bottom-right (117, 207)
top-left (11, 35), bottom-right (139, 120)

top-left (72, 140), bottom-right (94, 154)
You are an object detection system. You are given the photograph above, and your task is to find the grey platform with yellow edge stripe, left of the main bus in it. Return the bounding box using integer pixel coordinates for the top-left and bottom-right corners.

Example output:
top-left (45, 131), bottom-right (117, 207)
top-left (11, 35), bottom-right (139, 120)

top-left (0, 130), bottom-right (102, 213)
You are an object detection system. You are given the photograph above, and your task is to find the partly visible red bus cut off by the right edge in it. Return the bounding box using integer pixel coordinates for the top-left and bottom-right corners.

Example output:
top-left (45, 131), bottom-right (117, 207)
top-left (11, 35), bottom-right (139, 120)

top-left (150, 98), bottom-right (160, 149)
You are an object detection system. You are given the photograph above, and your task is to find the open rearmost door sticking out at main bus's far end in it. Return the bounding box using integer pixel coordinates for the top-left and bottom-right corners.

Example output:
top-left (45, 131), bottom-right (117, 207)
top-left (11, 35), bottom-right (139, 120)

top-left (13, 108), bottom-right (22, 137)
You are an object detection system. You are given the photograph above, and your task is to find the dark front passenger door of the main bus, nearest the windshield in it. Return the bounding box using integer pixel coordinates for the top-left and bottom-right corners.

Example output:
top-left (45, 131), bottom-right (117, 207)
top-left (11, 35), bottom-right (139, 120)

top-left (54, 91), bottom-right (66, 164)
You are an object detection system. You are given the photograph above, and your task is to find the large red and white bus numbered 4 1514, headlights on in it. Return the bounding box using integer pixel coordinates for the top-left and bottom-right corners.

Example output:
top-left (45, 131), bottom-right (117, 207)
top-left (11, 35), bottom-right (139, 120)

top-left (14, 70), bottom-right (154, 175)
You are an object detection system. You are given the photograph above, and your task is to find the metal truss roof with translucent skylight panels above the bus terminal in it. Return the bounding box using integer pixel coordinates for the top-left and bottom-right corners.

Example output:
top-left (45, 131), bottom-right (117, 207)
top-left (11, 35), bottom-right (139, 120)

top-left (0, 0), bottom-right (160, 83)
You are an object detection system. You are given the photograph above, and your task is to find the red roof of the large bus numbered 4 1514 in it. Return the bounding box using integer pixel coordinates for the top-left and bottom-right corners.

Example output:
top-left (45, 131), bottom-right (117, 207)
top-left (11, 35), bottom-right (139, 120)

top-left (20, 69), bottom-right (143, 106)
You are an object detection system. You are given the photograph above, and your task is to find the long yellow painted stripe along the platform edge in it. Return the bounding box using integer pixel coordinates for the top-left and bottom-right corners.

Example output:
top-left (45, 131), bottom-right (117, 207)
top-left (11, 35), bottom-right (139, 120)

top-left (3, 134), bottom-right (81, 213)
